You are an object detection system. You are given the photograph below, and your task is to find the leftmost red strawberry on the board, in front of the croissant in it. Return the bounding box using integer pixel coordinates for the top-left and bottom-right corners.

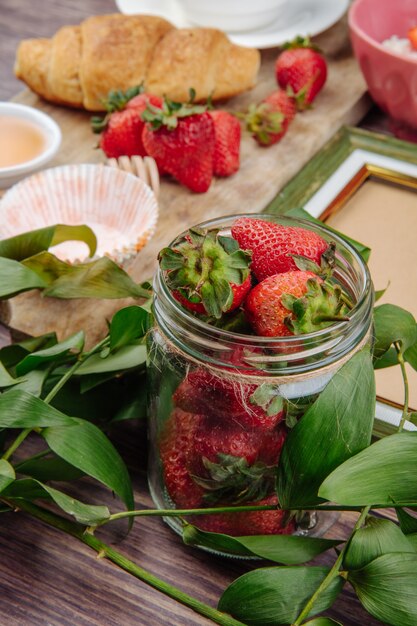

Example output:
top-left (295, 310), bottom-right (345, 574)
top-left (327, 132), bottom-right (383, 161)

top-left (91, 87), bottom-right (163, 158)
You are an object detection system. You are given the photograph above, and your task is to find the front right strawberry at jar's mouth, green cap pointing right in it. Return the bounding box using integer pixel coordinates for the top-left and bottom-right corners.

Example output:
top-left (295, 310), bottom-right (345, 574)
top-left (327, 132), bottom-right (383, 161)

top-left (245, 270), bottom-right (348, 337)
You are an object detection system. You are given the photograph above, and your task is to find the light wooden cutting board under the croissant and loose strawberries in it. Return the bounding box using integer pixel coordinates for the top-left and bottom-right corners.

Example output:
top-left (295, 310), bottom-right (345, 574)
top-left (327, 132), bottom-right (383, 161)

top-left (0, 19), bottom-right (370, 345)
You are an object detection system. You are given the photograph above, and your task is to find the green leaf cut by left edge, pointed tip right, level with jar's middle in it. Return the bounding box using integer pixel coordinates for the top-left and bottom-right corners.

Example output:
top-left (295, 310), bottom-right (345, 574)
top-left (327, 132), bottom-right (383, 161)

top-left (0, 389), bottom-right (76, 428)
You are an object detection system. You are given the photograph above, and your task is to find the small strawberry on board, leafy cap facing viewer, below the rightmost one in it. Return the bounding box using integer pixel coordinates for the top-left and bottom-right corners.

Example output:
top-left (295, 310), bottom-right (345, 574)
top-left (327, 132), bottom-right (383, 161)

top-left (245, 89), bottom-right (296, 146)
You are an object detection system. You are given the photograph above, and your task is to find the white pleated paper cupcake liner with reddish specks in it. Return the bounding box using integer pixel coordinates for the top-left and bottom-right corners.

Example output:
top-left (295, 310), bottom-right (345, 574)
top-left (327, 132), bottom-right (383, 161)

top-left (0, 163), bottom-right (158, 263)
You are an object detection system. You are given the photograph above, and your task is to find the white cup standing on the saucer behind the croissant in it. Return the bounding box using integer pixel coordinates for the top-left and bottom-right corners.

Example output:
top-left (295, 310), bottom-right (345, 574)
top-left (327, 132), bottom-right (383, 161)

top-left (177, 0), bottom-right (288, 32)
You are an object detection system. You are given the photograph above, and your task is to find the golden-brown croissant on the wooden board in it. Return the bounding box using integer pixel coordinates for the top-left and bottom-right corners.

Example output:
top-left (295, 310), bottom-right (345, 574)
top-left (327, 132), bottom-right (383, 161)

top-left (15, 14), bottom-right (260, 111)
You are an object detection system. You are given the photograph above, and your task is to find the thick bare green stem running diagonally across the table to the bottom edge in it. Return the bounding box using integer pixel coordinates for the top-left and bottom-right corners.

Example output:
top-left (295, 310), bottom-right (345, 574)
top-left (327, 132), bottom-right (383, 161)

top-left (5, 500), bottom-right (245, 626)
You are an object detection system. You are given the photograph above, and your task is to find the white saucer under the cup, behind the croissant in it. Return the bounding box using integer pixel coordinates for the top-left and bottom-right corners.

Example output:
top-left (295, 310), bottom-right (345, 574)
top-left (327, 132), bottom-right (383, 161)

top-left (115, 0), bottom-right (349, 49)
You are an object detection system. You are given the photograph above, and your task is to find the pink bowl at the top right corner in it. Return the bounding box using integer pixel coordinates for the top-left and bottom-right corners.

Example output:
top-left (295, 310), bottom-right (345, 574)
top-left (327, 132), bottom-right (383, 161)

top-left (349, 0), bottom-right (417, 127)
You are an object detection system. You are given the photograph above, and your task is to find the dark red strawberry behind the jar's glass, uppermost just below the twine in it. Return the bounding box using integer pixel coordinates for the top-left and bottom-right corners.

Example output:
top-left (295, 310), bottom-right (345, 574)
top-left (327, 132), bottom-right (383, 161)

top-left (173, 368), bottom-right (284, 431)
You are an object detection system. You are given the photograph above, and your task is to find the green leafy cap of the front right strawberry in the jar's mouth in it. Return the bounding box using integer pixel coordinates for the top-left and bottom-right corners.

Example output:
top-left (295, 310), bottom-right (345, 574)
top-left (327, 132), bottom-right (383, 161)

top-left (281, 278), bottom-right (350, 335)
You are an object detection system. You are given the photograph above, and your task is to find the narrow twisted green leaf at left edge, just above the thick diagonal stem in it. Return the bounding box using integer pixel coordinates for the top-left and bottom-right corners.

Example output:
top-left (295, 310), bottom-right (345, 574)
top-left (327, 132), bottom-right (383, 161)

top-left (3, 478), bottom-right (110, 525)
